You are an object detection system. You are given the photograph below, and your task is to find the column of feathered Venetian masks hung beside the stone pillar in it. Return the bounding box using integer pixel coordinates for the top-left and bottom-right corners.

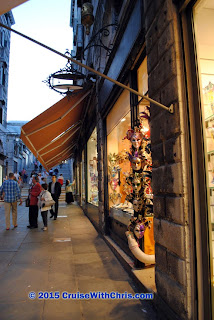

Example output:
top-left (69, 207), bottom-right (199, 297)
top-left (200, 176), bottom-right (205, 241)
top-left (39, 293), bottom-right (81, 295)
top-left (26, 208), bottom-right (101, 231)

top-left (126, 114), bottom-right (155, 264)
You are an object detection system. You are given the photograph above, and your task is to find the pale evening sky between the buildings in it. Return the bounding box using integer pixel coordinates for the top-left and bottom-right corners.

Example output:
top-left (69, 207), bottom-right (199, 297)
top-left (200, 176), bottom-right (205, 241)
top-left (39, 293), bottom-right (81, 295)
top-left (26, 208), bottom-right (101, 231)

top-left (7, 0), bottom-right (73, 121)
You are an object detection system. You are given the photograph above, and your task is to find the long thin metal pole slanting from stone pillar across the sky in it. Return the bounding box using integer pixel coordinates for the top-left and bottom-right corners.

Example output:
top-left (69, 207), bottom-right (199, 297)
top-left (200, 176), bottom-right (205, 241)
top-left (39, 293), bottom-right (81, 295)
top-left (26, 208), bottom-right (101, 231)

top-left (0, 23), bottom-right (174, 113)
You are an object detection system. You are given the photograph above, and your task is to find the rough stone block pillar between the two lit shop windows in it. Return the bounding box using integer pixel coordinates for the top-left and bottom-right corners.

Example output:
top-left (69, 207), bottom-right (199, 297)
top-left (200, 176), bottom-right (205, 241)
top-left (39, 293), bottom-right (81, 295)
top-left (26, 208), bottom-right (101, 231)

top-left (144, 0), bottom-right (193, 319)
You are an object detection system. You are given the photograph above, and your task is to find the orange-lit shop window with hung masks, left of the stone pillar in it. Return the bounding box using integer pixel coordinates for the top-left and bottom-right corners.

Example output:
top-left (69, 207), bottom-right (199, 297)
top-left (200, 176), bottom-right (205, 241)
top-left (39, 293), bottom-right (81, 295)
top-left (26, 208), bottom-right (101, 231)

top-left (106, 58), bottom-right (154, 266)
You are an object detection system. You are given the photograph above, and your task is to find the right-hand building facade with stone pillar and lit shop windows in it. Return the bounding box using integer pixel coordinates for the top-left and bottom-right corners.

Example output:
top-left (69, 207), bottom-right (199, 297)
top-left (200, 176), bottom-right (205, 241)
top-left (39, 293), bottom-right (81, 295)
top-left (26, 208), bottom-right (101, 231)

top-left (71, 0), bottom-right (214, 319)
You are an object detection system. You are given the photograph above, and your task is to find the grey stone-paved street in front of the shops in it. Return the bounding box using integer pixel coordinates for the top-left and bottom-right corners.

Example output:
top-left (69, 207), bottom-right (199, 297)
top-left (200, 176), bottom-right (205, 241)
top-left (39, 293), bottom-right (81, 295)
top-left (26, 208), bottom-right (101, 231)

top-left (0, 202), bottom-right (156, 320)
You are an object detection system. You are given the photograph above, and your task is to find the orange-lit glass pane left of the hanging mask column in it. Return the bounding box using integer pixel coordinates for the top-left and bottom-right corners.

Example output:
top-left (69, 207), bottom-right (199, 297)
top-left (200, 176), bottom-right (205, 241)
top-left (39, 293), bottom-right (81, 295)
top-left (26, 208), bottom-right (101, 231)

top-left (107, 91), bottom-right (131, 207)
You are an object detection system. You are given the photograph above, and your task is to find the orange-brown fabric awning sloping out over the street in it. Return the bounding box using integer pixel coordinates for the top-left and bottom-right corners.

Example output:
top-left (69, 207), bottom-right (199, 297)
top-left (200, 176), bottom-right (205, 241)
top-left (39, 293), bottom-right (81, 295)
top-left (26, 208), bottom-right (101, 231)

top-left (20, 90), bottom-right (90, 170)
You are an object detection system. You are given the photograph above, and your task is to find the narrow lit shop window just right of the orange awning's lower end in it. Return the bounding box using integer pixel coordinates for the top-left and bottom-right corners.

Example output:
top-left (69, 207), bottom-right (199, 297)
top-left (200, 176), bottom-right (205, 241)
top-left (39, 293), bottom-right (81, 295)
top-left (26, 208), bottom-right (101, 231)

top-left (87, 128), bottom-right (98, 206)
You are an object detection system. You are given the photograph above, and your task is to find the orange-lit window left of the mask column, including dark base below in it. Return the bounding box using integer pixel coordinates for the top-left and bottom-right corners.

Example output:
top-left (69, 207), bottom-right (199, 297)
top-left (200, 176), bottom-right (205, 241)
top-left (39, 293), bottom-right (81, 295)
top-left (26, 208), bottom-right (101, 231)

top-left (106, 91), bottom-right (133, 254)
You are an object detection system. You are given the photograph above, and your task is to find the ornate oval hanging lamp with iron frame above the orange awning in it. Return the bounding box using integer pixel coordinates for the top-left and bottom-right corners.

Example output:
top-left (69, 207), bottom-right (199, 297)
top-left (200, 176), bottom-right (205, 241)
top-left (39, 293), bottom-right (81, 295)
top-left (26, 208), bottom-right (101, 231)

top-left (43, 50), bottom-right (85, 94)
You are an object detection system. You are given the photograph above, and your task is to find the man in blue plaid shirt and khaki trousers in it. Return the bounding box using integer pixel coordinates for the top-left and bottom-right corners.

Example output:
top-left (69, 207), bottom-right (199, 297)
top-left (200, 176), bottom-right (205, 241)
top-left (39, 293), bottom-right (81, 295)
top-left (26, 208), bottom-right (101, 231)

top-left (0, 172), bottom-right (22, 230)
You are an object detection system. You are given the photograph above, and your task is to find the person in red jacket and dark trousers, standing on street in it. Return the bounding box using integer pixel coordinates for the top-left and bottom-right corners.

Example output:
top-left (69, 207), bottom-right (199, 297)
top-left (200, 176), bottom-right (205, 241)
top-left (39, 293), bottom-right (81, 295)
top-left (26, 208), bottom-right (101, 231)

top-left (27, 177), bottom-right (42, 229)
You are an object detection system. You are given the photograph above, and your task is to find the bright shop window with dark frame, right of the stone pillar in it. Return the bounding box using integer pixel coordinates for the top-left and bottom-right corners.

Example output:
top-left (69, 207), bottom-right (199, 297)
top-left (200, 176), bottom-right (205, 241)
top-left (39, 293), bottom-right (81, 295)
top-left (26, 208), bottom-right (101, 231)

top-left (181, 0), bottom-right (214, 319)
